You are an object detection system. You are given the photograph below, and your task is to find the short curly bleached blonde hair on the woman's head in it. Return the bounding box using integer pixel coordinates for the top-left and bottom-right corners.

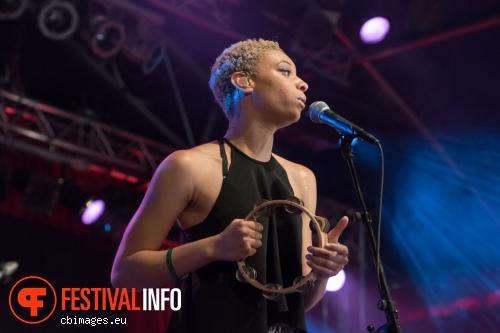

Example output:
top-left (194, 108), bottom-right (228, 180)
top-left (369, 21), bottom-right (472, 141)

top-left (209, 39), bottom-right (283, 119)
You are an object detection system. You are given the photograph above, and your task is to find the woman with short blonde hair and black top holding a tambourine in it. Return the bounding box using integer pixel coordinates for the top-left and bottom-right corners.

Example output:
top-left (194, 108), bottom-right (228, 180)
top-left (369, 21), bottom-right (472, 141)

top-left (112, 40), bottom-right (348, 333)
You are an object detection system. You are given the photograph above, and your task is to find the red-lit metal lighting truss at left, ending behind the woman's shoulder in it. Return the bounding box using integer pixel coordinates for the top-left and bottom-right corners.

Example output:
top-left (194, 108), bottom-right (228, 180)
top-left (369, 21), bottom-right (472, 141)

top-left (0, 90), bottom-right (174, 183)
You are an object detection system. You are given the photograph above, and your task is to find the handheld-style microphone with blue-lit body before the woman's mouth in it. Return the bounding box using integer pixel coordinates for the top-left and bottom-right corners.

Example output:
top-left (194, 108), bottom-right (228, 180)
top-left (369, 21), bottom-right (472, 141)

top-left (309, 102), bottom-right (379, 144)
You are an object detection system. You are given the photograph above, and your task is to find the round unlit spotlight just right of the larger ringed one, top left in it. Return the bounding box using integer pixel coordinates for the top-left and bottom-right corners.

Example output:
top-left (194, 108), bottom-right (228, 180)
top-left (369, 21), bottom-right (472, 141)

top-left (89, 16), bottom-right (125, 58)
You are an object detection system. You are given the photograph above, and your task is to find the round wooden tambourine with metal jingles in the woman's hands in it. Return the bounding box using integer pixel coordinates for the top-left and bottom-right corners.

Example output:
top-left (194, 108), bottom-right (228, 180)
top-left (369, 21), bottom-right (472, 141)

top-left (236, 197), bottom-right (330, 301)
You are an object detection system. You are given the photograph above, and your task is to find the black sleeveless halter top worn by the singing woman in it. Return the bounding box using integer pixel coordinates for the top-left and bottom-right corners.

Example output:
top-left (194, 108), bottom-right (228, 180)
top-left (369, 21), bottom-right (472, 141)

top-left (166, 139), bottom-right (306, 333)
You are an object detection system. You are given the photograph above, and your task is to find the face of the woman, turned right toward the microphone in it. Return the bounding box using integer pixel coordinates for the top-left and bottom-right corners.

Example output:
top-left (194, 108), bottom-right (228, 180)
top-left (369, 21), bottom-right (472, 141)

top-left (251, 50), bottom-right (308, 125)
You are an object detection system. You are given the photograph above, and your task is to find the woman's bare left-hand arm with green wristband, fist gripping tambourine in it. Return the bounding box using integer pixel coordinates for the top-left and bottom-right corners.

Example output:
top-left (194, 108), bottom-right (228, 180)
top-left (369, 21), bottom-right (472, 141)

top-left (111, 151), bottom-right (262, 288)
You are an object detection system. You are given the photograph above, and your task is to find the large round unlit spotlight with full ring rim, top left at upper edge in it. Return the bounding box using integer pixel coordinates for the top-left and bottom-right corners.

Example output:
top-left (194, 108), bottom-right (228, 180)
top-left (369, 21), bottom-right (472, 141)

top-left (38, 0), bottom-right (79, 40)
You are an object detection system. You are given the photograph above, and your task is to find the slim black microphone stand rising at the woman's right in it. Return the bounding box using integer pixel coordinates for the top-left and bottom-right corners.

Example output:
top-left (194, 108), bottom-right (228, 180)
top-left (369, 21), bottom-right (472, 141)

top-left (340, 134), bottom-right (403, 333)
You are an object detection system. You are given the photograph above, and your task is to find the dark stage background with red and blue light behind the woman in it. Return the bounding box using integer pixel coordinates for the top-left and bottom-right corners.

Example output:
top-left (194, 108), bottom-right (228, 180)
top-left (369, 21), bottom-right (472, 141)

top-left (0, 0), bottom-right (500, 333)
